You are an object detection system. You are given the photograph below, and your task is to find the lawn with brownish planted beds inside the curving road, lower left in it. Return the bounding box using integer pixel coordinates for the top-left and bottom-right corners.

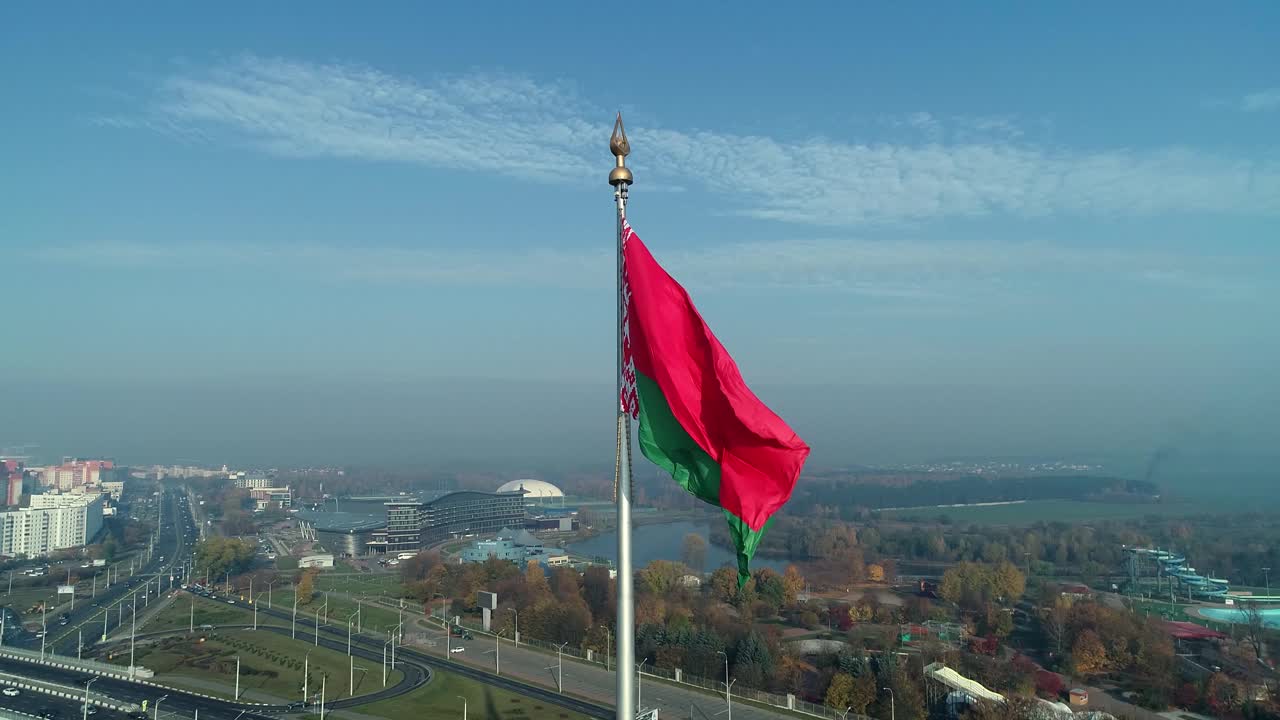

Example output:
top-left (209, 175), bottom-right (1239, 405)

top-left (109, 625), bottom-right (401, 700)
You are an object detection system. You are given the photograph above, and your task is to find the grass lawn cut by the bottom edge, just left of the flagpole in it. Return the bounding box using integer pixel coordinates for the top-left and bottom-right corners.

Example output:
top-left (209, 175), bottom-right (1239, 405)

top-left (357, 671), bottom-right (586, 720)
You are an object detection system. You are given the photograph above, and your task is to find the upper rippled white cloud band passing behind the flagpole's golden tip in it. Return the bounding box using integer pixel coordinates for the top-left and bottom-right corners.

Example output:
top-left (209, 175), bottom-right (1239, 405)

top-left (104, 56), bottom-right (1280, 225)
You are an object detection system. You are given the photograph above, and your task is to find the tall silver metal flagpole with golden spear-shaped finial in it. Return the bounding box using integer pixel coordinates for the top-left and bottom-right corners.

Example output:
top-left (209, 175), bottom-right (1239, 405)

top-left (609, 113), bottom-right (639, 720)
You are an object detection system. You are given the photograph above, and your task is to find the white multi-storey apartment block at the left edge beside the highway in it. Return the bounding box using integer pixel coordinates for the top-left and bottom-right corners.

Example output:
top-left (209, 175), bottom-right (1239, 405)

top-left (0, 495), bottom-right (104, 557)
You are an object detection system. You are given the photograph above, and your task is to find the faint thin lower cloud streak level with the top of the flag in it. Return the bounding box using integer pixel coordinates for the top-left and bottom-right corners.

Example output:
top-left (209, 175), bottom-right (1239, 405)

top-left (31, 238), bottom-right (1251, 305)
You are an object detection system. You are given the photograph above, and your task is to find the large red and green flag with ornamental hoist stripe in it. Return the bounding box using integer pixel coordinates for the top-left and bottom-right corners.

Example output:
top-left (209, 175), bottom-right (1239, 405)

top-left (621, 224), bottom-right (809, 584)
